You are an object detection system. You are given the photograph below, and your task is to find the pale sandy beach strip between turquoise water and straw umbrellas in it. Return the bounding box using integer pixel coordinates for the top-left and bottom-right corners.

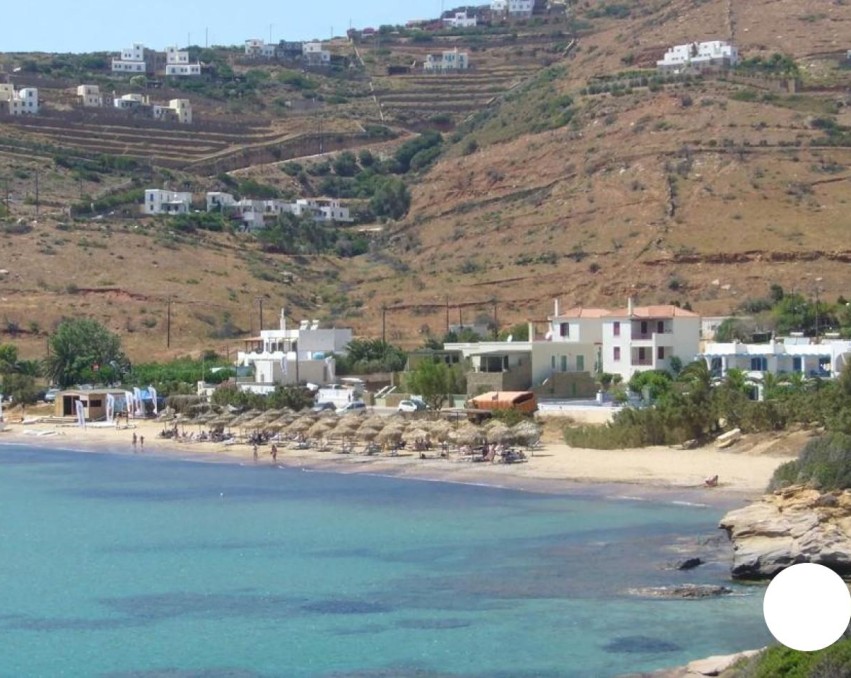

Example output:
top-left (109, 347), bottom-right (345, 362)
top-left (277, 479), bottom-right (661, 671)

top-left (0, 412), bottom-right (806, 500)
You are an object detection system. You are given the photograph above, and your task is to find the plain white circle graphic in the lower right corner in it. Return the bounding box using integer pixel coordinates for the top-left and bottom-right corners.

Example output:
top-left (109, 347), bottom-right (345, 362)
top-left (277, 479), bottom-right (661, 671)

top-left (762, 563), bottom-right (851, 652)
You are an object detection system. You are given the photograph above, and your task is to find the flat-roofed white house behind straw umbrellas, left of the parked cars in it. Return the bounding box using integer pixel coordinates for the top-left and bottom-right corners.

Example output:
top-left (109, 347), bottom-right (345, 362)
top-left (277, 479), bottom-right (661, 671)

top-left (236, 309), bottom-right (353, 393)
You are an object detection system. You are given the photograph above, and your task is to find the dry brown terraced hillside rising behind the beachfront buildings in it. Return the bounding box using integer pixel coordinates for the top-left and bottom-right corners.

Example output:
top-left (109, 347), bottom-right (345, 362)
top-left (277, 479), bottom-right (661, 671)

top-left (0, 0), bottom-right (851, 364)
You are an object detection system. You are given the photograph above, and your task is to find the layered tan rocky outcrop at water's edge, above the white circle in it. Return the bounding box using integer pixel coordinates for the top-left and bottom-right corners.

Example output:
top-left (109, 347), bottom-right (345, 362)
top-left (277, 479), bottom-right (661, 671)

top-left (720, 486), bottom-right (851, 579)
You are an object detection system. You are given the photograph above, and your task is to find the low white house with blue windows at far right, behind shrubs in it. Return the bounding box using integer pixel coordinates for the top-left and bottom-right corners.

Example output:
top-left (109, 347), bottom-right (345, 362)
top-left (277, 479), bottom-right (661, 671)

top-left (700, 337), bottom-right (851, 381)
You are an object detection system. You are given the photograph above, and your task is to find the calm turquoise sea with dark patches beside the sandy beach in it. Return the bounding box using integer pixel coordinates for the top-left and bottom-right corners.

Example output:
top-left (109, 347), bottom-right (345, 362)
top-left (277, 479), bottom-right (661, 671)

top-left (0, 445), bottom-right (771, 678)
